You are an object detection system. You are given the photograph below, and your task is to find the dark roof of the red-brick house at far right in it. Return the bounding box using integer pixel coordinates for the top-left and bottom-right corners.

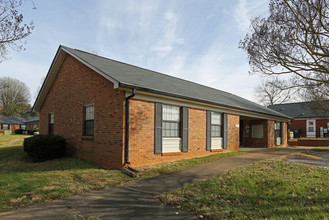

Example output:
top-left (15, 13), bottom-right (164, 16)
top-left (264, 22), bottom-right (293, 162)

top-left (268, 102), bottom-right (328, 118)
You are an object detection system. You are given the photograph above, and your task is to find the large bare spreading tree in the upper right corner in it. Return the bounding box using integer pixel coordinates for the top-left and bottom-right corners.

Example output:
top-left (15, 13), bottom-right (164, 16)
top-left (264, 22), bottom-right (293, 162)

top-left (239, 0), bottom-right (329, 86)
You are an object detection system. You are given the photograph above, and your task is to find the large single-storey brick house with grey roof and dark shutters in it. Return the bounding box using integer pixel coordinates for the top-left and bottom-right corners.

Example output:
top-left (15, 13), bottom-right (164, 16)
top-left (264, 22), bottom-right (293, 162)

top-left (33, 46), bottom-right (291, 169)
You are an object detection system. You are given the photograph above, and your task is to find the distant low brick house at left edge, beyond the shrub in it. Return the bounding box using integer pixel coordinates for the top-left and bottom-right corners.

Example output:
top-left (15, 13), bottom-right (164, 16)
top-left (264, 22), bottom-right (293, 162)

top-left (0, 116), bottom-right (39, 134)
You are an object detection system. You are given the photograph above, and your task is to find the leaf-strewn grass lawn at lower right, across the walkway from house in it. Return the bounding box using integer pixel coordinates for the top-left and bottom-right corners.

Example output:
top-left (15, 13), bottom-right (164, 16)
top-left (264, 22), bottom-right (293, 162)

top-left (159, 161), bottom-right (329, 219)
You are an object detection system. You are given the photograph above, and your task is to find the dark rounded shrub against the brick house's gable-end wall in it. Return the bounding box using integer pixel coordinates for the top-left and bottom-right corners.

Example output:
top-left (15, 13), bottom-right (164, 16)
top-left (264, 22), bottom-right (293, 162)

top-left (24, 134), bottom-right (66, 162)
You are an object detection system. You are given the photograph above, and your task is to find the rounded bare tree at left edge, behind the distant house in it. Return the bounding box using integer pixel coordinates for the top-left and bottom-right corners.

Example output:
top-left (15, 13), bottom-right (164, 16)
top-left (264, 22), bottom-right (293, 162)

top-left (0, 77), bottom-right (31, 116)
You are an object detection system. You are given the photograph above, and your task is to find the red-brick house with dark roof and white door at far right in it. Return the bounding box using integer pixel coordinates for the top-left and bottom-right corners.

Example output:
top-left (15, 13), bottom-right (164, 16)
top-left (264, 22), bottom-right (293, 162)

top-left (268, 102), bottom-right (329, 137)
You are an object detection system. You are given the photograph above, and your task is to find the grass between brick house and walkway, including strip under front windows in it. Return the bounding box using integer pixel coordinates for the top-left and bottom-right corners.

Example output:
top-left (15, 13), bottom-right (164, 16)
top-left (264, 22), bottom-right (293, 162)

top-left (0, 135), bottom-right (243, 212)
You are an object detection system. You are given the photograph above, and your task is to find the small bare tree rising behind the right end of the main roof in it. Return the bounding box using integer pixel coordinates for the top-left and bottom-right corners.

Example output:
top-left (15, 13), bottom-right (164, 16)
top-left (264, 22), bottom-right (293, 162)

top-left (254, 77), bottom-right (298, 106)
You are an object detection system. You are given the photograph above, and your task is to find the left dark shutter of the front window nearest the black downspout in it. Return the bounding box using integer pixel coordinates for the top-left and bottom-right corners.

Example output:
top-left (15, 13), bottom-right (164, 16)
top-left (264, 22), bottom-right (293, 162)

top-left (154, 103), bottom-right (162, 154)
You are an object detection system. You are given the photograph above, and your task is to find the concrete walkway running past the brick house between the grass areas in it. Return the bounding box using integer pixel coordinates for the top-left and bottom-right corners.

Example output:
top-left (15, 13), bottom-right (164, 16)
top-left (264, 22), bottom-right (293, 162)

top-left (0, 148), bottom-right (305, 219)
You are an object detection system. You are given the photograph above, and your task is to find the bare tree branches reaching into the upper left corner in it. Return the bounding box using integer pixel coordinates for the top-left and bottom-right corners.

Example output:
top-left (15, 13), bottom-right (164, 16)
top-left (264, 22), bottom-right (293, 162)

top-left (0, 0), bottom-right (34, 62)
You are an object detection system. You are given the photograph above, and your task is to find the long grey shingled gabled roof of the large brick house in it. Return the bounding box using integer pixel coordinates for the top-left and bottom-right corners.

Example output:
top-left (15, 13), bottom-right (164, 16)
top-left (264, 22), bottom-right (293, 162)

top-left (33, 46), bottom-right (290, 118)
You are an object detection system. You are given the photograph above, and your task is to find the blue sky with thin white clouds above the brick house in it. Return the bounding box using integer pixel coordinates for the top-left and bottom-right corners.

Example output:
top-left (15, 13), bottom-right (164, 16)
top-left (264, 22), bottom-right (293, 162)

top-left (0, 0), bottom-right (268, 104)
